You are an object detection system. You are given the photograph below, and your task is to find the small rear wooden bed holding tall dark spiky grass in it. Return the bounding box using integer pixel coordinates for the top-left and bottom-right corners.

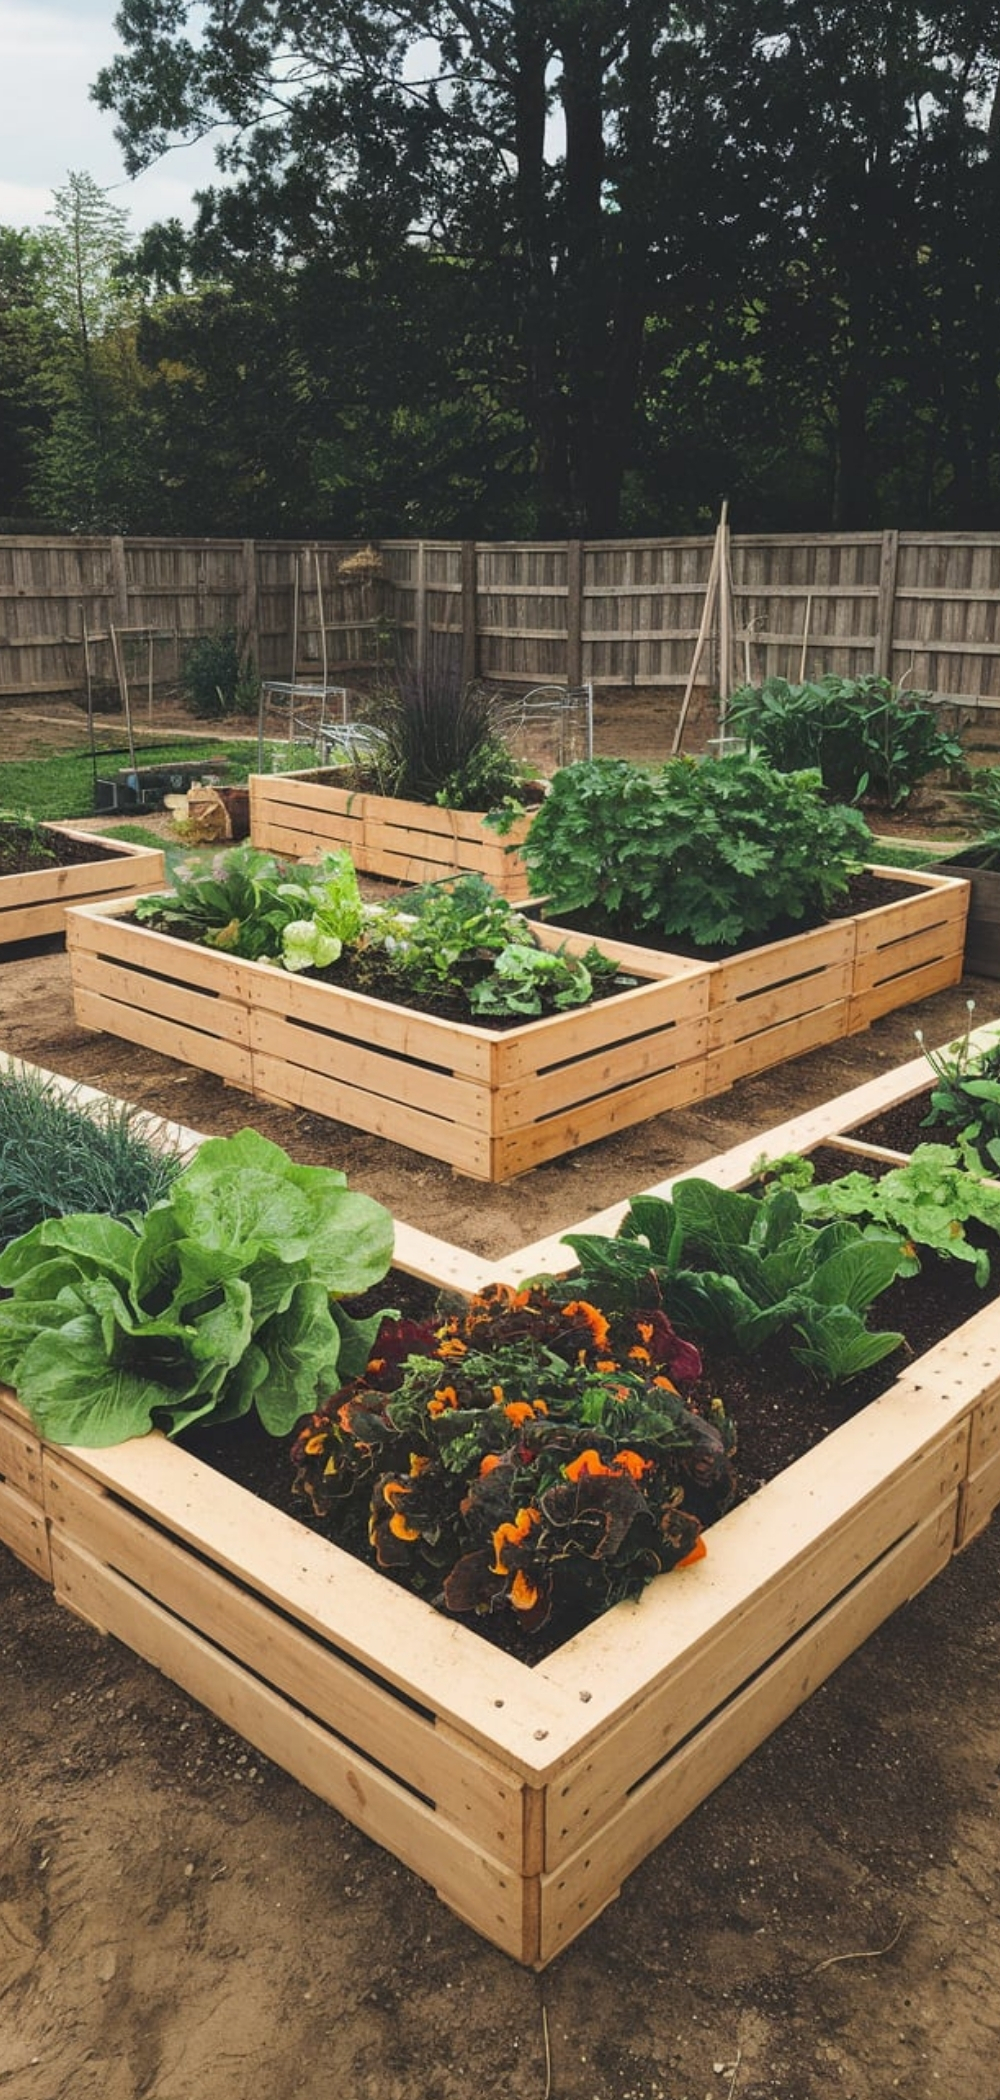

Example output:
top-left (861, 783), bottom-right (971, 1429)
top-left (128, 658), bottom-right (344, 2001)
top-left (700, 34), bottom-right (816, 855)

top-left (250, 767), bottom-right (532, 903)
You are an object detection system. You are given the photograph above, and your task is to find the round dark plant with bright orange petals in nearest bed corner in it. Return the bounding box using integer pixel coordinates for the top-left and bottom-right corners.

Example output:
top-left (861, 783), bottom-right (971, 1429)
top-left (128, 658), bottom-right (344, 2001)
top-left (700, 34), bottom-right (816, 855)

top-left (292, 1283), bottom-right (735, 1638)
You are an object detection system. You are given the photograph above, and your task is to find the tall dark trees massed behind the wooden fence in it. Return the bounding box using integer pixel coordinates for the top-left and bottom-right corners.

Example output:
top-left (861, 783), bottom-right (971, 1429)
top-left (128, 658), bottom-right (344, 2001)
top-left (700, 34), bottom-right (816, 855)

top-left (0, 0), bottom-right (1000, 536)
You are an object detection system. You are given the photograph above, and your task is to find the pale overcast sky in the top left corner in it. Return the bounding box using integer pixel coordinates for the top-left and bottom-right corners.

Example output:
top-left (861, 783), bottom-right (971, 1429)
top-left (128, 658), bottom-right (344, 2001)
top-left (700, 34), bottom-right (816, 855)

top-left (0, 0), bottom-right (212, 233)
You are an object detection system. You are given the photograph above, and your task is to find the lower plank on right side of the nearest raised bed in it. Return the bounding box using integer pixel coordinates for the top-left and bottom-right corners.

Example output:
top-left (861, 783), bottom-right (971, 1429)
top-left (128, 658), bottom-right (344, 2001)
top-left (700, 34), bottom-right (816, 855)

top-left (538, 1495), bottom-right (958, 1966)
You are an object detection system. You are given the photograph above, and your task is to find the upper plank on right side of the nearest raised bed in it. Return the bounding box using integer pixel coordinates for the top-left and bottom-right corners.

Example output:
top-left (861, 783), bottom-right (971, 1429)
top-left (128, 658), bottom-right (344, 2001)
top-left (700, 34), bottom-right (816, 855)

top-left (546, 1422), bottom-right (968, 1867)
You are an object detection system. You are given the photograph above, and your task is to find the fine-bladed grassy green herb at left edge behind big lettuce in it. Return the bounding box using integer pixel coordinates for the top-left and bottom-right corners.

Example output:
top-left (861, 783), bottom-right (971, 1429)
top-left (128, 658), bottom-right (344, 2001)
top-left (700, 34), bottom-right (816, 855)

top-left (0, 1067), bottom-right (181, 1245)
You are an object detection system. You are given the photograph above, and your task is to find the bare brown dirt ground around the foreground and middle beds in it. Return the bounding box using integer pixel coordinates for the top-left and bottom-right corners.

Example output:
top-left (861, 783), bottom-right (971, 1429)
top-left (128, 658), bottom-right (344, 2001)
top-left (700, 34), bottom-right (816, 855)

top-left (0, 716), bottom-right (1000, 2100)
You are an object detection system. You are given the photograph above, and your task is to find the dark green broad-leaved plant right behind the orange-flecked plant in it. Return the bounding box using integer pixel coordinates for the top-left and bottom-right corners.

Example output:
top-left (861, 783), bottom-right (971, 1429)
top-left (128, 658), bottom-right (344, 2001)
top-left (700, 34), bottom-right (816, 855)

top-left (565, 1176), bottom-right (903, 1384)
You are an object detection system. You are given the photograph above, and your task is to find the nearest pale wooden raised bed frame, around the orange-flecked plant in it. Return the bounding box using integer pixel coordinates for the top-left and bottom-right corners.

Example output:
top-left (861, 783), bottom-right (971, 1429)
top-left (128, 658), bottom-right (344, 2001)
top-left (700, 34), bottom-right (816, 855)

top-left (0, 1041), bottom-right (1000, 1968)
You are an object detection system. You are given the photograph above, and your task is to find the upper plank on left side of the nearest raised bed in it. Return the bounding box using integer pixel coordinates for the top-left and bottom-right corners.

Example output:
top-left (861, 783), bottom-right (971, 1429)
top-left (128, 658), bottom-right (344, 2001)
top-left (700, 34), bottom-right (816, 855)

top-left (46, 1455), bottom-right (531, 1865)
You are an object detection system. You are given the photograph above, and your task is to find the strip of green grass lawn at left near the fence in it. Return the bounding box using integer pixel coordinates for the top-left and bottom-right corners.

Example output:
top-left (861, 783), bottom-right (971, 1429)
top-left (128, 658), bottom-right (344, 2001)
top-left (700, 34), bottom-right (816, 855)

top-left (0, 737), bottom-right (315, 823)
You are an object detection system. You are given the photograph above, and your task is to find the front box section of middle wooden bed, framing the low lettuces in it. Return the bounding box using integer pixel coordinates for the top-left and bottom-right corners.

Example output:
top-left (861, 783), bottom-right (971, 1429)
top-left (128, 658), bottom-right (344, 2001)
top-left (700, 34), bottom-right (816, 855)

top-left (67, 905), bottom-right (708, 1182)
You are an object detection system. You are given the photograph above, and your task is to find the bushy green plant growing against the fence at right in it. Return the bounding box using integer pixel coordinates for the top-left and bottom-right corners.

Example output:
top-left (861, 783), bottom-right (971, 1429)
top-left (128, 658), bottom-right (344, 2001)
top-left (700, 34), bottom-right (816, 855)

top-left (727, 676), bottom-right (964, 809)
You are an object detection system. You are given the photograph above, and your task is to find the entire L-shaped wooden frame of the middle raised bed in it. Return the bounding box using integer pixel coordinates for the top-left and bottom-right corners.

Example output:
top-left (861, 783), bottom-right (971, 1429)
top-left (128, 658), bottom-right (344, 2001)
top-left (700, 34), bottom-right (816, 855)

top-left (67, 874), bottom-right (968, 1182)
